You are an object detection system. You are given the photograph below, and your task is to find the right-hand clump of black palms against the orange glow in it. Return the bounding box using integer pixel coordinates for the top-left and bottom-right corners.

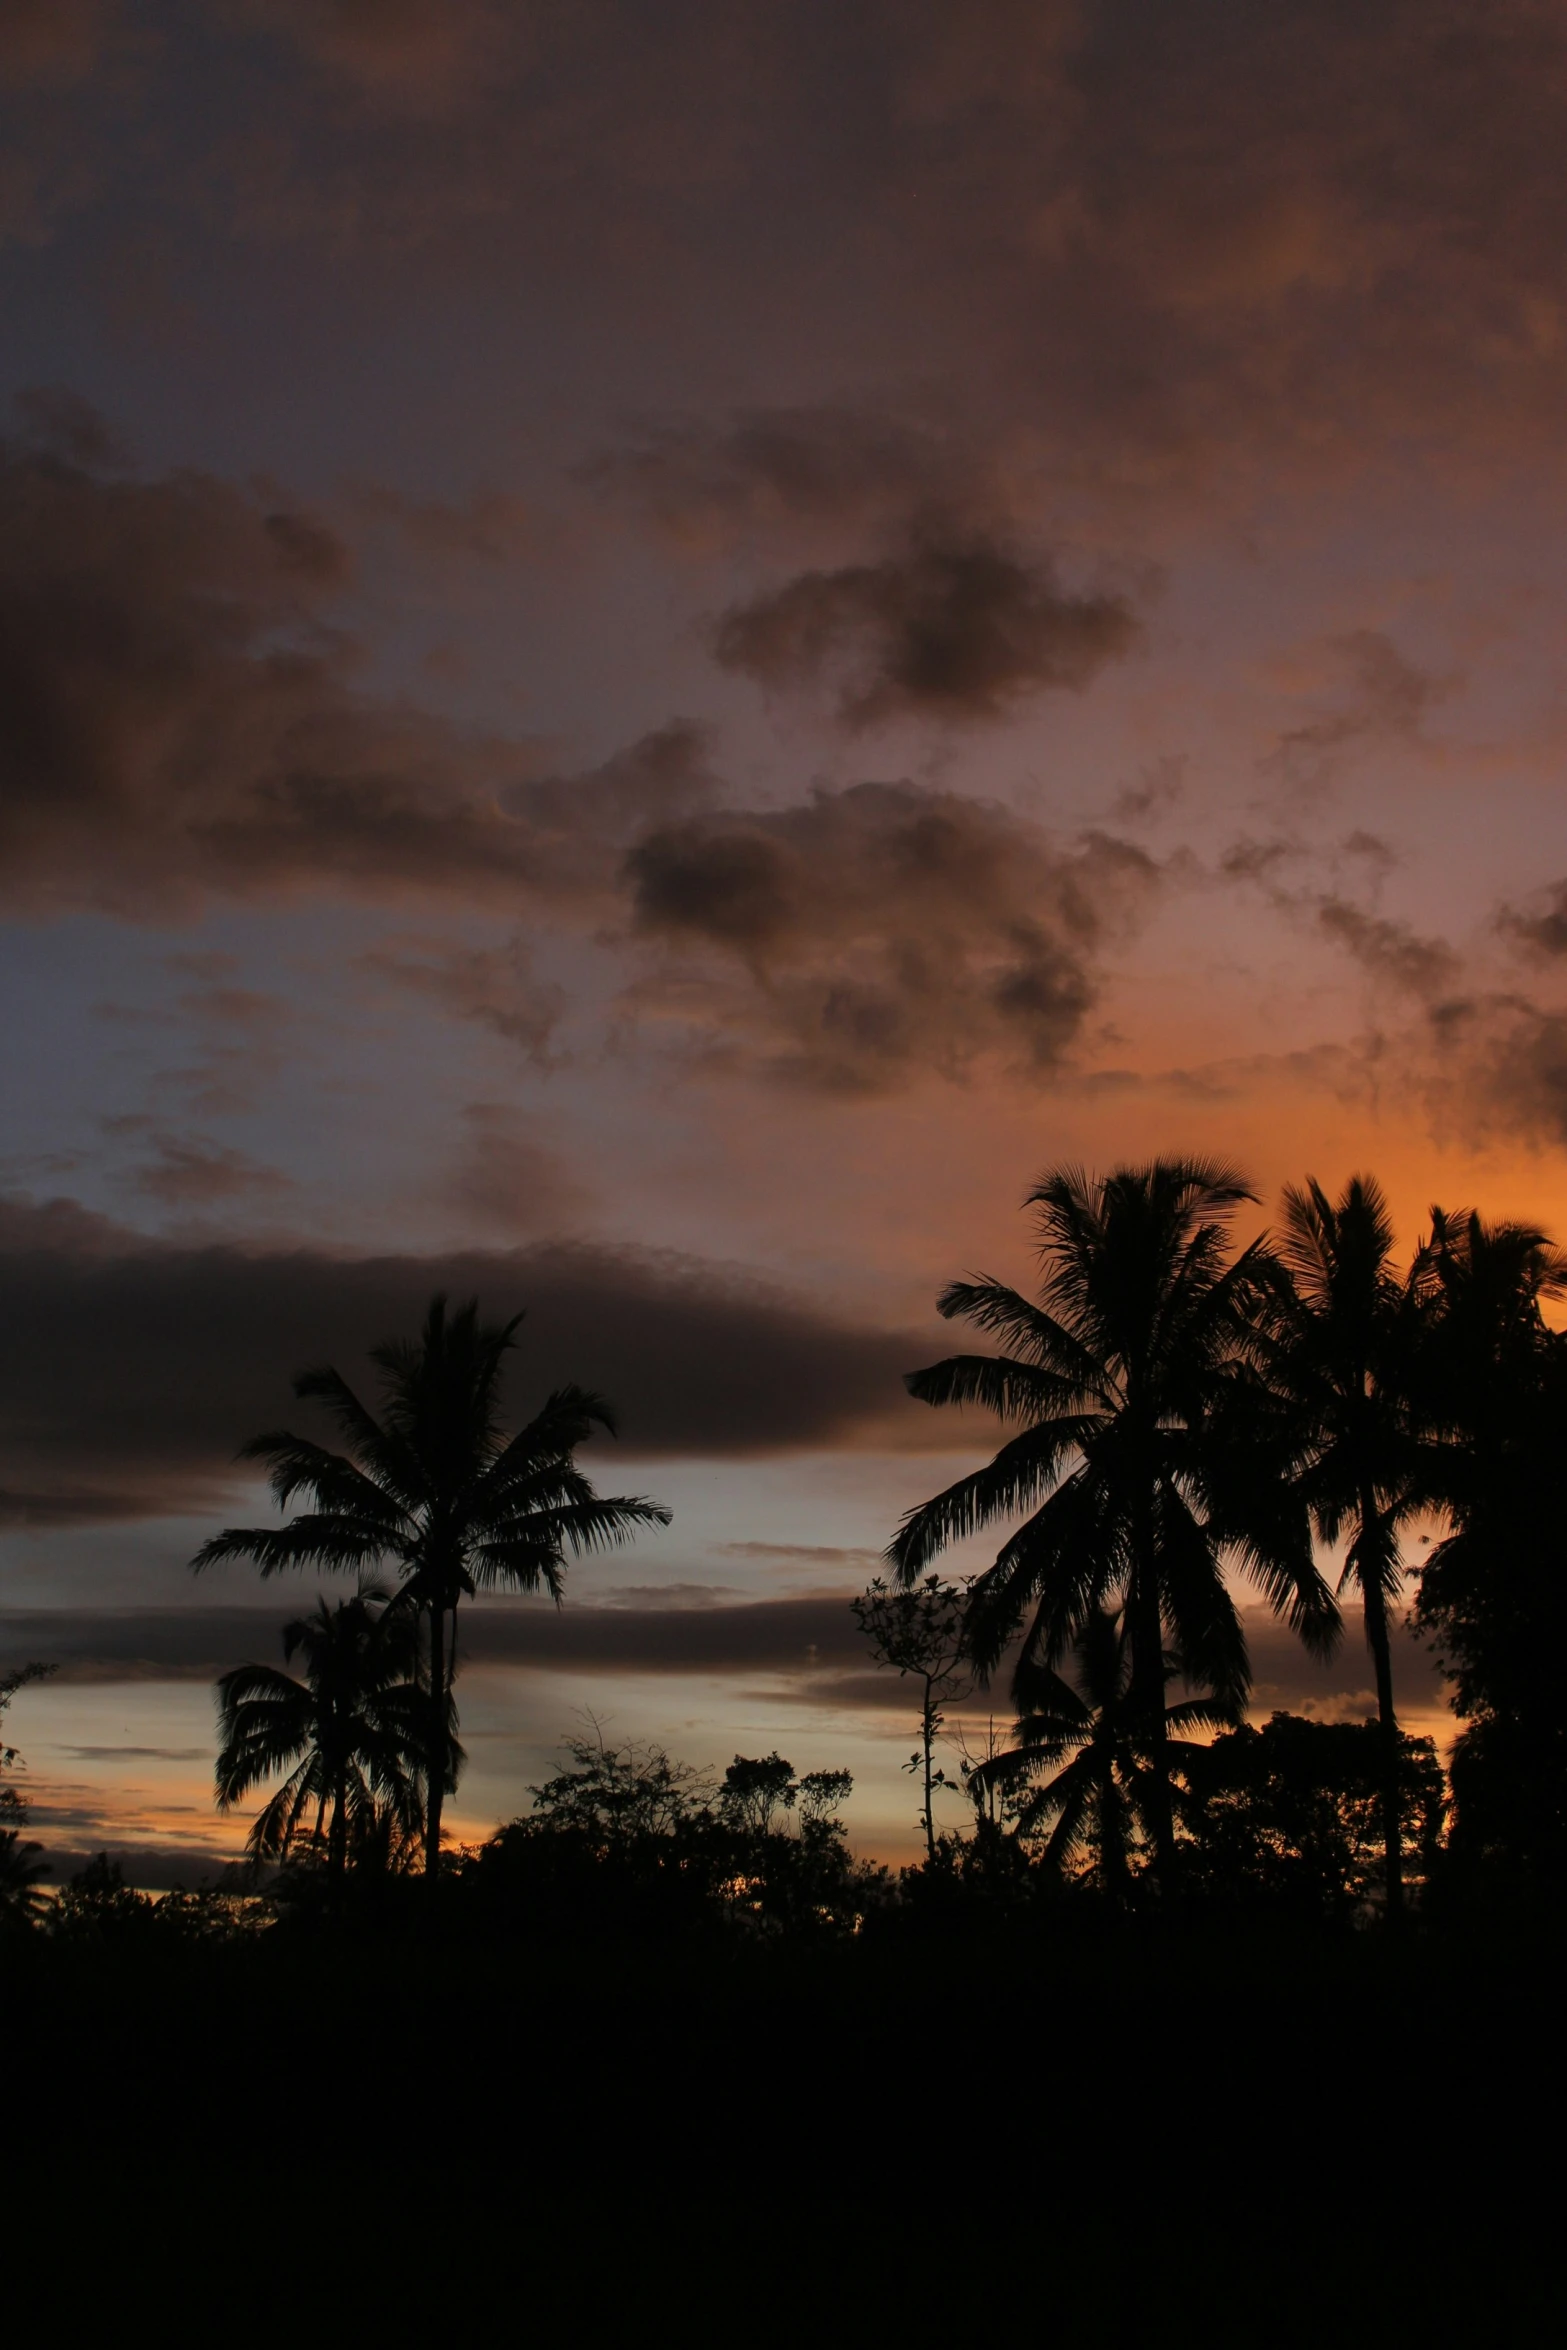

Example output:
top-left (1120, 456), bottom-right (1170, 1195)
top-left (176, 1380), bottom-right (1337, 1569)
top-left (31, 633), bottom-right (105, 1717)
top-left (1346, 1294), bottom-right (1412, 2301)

top-left (883, 1161), bottom-right (1567, 1911)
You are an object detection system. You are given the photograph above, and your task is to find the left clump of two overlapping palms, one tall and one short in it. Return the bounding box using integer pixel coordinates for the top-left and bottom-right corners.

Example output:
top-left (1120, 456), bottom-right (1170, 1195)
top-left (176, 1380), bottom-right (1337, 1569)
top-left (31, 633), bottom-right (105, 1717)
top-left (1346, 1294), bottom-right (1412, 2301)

top-left (193, 1295), bottom-right (670, 1875)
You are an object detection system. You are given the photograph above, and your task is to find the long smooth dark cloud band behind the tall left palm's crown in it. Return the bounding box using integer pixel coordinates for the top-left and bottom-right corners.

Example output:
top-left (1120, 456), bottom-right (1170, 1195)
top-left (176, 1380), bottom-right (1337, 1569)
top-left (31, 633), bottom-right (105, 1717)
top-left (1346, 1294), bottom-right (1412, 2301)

top-left (0, 1201), bottom-right (930, 1523)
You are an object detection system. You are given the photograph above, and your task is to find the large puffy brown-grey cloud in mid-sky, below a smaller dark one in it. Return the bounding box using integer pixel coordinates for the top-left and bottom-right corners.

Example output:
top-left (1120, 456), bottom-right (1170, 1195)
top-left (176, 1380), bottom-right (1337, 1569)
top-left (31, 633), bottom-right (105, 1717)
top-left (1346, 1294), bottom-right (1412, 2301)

top-left (627, 783), bottom-right (1158, 1090)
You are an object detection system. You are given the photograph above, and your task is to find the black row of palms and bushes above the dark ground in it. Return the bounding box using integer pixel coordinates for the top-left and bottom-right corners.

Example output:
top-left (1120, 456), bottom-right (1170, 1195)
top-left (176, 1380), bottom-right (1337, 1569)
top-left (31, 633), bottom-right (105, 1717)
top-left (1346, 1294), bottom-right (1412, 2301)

top-left (0, 1161), bottom-right (1567, 1941)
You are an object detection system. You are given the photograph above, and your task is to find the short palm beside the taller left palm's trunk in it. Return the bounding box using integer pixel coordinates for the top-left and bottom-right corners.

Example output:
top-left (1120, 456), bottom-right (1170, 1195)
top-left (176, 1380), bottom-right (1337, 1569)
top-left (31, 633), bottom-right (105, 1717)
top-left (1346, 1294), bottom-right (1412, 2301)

top-left (216, 1591), bottom-right (425, 1882)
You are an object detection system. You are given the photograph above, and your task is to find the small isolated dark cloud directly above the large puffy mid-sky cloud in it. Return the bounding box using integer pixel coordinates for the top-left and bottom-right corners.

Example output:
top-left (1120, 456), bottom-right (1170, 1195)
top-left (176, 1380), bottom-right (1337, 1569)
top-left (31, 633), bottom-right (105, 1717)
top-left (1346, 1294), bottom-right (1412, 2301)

top-left (714, 533), bottom-right (1137, 726)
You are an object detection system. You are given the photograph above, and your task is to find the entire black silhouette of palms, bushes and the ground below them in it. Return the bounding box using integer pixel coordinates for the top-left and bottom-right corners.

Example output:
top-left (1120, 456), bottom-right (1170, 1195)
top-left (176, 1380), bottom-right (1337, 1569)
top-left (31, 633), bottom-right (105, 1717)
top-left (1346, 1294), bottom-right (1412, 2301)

top-left (0, 1163), bottom-right (1567, 2343)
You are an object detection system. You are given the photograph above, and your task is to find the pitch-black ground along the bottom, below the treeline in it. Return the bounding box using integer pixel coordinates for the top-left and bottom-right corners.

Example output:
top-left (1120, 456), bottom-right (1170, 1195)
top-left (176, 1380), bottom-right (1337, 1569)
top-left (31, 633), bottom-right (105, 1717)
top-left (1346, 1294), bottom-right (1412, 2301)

top-left (2, 1918), bottom-right (1567, 2345)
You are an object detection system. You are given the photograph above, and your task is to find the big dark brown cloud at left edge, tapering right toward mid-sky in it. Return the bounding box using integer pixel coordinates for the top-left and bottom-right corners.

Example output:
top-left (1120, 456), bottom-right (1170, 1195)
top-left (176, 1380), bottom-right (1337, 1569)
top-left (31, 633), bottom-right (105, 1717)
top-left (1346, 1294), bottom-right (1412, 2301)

top-left (0, 432), bottom-right (714, 917)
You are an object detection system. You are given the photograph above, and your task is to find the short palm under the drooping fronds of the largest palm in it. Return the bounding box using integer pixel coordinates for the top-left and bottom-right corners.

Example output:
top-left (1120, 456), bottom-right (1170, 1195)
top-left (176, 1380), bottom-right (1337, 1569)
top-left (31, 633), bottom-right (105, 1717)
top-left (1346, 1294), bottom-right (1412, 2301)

top-left (973, 1607), bottom-right (1238, 1894)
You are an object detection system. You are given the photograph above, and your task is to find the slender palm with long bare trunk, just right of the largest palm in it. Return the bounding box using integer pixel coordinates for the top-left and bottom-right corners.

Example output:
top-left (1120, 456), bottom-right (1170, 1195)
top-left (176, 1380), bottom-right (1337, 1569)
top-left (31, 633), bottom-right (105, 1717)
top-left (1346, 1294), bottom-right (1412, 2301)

top-left (1266, 1175), bottom-right (1438, 1915)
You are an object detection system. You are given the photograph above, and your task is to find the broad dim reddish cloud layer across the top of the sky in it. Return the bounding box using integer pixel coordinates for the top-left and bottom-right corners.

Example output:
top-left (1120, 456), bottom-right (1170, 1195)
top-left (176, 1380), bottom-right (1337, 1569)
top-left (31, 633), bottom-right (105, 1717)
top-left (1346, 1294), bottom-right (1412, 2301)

top-left (18, 0), bottom-right (1567, 501)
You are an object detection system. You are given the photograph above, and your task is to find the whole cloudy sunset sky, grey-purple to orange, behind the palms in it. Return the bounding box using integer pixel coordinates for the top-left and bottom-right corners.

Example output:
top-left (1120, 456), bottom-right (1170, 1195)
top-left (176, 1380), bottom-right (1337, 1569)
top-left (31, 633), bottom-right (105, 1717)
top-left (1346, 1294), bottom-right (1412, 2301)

top-left (0, 0), bottom-right (1567, 1882)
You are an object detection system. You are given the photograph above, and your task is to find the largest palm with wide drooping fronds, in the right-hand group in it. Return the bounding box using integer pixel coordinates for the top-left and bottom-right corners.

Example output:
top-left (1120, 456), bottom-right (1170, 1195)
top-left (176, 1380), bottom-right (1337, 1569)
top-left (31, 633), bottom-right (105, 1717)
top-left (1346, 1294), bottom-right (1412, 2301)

top-left (888, 1159), bottom-right (1337, 1873)
